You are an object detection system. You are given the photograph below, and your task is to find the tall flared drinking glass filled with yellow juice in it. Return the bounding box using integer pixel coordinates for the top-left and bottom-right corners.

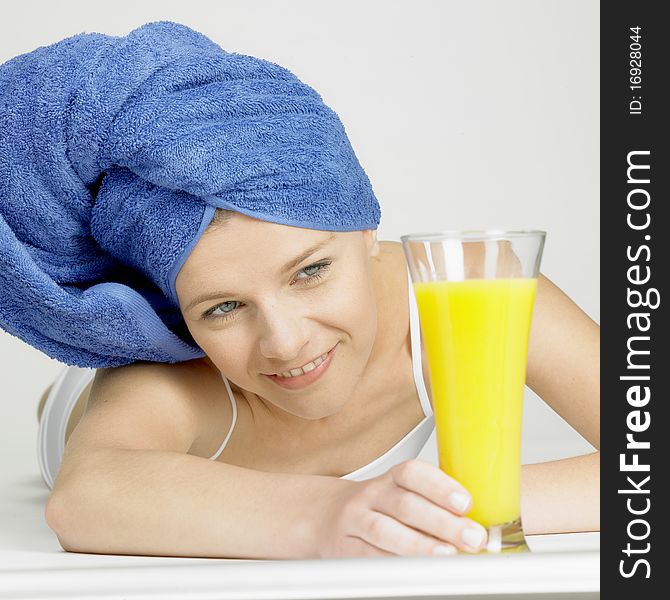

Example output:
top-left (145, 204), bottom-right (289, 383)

top-left (400, 230), bottom-right (546, 552)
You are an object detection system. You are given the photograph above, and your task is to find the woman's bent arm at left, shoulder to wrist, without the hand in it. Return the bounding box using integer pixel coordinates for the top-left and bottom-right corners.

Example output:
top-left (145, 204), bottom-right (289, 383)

top-left (45, 361), bottom-right (346, 559)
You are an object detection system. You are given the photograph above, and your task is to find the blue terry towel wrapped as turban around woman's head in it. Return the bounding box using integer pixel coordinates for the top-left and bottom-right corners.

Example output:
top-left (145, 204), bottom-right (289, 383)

top-left (0, 21), bottom-right (381, 368)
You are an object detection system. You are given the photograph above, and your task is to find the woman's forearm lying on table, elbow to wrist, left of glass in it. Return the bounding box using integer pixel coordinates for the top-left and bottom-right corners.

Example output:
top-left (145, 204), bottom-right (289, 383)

top-left (46, 448), bottom-right (346, 559)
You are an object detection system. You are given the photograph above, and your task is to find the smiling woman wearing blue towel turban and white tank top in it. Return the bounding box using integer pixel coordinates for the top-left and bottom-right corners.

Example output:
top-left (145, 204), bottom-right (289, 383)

top-left (0, 22), bottom-right (599, 559)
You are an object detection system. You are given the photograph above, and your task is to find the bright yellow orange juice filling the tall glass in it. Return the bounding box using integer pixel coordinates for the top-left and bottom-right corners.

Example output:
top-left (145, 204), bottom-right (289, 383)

top-left (413, 278), bottom-right (537, 527)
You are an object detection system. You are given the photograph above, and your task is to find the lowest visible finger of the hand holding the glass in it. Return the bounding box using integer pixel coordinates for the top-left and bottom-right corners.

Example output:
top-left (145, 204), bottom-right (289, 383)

top-left (355, 510), bottom-right (456, 556)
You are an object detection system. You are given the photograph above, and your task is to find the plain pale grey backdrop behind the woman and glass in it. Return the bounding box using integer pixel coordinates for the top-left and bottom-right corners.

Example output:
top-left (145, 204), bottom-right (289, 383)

top-left (0, 0), bottom-right (600, 506)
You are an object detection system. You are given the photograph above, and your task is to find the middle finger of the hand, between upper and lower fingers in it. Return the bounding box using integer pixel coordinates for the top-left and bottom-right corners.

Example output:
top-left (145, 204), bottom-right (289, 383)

top-left (371, 487), bottom-right (486, 552)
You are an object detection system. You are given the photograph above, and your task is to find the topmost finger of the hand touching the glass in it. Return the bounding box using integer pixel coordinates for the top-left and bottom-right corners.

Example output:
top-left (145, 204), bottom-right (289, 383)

top-left (388, 459), bottom-right (472, 515)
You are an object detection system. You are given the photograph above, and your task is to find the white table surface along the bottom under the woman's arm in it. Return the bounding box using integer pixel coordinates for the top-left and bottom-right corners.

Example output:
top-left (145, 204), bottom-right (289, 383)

top-left (0, 533), bottom-right (600, 600)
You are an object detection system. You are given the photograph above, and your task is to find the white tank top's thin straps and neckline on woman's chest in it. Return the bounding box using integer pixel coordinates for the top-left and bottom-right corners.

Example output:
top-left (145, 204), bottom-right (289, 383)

top-left (210, 270), bottom-right (435, 481)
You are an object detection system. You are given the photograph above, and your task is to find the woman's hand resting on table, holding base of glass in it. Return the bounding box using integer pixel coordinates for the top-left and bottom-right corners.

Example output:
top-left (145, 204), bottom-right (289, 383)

top-left (317, 459), bottom-right (486, 558)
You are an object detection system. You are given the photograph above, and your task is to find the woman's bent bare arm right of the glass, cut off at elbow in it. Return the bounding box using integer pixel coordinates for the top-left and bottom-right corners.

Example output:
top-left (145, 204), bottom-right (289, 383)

top-left (521, 275), bottom-right (600, 534)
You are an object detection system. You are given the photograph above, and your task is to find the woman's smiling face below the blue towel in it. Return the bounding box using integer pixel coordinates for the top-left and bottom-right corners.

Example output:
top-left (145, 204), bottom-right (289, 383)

top-left (175, 213), bottom-right (379, 420)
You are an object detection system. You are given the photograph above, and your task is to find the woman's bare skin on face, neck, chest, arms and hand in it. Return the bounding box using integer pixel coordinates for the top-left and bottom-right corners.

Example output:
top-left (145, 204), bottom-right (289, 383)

top-left (38, 209), bottom-right (599, 558)
